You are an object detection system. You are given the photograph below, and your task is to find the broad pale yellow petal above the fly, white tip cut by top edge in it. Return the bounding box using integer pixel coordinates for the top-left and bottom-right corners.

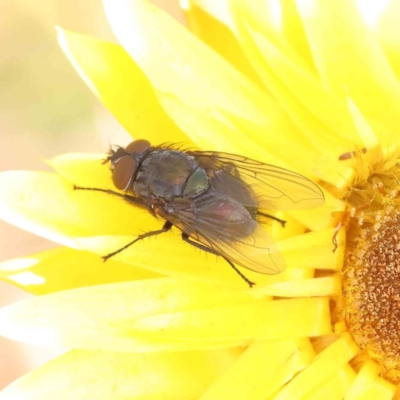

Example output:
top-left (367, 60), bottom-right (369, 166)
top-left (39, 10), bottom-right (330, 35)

top-left (104, 0), bottom-right (276, 124)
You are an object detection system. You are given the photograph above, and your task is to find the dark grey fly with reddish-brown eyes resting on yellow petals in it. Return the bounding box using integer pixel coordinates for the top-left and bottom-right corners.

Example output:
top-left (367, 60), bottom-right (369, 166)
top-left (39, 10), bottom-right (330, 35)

top-left (75, 139), bottom-right (324, 287)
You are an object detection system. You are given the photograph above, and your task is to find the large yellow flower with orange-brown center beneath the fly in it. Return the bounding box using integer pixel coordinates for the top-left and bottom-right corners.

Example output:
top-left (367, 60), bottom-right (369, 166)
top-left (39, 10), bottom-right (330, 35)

top-left (0, 0), bottom-right (400, 400)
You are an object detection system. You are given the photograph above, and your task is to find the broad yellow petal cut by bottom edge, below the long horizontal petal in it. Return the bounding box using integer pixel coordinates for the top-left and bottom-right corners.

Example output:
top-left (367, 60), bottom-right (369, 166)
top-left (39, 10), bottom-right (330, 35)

top-left (200, 339), bottom-right (314, 400)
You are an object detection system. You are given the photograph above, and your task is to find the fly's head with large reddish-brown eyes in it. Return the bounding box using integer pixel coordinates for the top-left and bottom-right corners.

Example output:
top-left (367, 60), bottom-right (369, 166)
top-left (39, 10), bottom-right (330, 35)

top-left (103, 139), bottom-right (151, 191)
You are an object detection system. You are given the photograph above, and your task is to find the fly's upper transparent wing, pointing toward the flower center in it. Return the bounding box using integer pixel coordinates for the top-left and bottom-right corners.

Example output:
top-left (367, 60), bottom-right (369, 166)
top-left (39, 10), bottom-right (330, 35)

top-left (188, 151), bottom-right (324, 210)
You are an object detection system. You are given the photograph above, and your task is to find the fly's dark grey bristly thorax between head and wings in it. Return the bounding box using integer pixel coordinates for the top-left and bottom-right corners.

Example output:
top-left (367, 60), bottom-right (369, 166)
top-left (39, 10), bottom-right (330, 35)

top-left (133, 149), bottom-right (208, 201)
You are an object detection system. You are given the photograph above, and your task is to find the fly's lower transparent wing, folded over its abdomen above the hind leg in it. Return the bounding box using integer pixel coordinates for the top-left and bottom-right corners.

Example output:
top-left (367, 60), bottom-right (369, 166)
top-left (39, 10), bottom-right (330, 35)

top-left (167, 193), bottom-right (285, 274)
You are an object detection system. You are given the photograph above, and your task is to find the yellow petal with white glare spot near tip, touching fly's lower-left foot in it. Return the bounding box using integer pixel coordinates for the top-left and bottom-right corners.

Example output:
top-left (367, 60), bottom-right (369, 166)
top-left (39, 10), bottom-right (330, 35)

top-left (0, 248), bottom-right (159, 294)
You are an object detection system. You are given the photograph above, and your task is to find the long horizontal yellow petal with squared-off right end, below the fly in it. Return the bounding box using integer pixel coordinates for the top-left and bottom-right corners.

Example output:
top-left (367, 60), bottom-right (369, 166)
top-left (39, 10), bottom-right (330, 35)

top-left (132, 298), bottom-right (331, 343)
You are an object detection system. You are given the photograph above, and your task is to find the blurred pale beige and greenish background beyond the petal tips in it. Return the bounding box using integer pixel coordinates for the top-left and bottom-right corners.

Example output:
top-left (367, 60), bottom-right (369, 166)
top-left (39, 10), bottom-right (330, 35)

top-left (0, 0), bottom-right (184, 390)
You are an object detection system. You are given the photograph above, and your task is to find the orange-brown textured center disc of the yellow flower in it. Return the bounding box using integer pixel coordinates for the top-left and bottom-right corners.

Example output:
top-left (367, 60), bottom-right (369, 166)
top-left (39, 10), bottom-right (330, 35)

top-left (343, 191), bottom-right (400, 383)
